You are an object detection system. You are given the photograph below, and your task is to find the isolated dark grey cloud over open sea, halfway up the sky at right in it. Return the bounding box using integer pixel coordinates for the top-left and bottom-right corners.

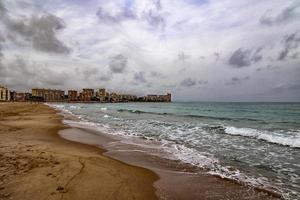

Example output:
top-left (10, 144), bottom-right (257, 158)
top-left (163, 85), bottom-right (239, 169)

top-left (228, 48), bottom-right (262, 68)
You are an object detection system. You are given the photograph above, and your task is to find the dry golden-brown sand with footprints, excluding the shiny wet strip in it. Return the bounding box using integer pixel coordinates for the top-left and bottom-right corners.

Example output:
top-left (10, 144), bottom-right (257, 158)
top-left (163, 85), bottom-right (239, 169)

top-left (0, 103), bottom-right (158, 200)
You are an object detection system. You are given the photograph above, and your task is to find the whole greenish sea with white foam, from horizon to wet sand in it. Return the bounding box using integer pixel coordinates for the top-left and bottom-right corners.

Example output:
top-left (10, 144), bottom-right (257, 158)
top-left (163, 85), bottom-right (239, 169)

top-left (51, 103), bottom-right (300, 199)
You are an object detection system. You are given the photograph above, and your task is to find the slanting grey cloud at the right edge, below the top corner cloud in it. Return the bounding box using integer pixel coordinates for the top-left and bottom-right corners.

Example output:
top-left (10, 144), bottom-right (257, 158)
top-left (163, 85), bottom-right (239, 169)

top-left (278, 32), bottom-right (300, 61)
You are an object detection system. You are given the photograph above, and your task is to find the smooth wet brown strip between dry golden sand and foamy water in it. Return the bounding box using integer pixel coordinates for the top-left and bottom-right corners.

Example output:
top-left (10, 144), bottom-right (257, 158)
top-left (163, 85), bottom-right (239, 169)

top-left (55, 104), bottom-right (282, 199)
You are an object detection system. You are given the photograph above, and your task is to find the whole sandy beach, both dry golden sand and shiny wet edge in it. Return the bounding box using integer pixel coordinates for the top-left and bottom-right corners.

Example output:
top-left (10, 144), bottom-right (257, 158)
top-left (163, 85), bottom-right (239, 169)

top-left (0, 103), bottom-right (281, 199)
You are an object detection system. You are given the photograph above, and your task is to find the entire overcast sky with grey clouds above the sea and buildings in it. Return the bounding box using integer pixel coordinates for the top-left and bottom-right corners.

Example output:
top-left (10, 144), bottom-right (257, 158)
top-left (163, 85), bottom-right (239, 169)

top-left (0, 0), bottom-right (300, 101)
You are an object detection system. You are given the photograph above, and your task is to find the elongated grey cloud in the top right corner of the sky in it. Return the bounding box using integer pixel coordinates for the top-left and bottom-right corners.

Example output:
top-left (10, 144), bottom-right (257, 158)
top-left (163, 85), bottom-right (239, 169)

top-left (260, 3), bottom-right (300, 26)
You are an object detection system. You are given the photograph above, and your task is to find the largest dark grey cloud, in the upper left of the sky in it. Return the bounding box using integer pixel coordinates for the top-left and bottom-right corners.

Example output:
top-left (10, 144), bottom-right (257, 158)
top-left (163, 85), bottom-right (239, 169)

top-left (4, 14), bottom-right (70, 54)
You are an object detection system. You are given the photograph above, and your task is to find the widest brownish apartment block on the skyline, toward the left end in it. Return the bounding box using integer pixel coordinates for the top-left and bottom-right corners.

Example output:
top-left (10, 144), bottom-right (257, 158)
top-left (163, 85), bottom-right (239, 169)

top-left (32, 88), bottom-right (65, 102)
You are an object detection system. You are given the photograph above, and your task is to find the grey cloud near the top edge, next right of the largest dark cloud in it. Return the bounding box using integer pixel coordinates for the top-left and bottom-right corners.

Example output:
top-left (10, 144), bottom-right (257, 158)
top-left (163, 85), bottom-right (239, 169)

top-left (96, 7), bottom-right (136, 23)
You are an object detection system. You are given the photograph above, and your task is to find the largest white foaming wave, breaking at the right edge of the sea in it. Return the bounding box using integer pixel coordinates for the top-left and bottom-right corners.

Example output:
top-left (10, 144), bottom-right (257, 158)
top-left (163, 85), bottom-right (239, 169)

top-left (224, 127), bottom-right (300, 148)
